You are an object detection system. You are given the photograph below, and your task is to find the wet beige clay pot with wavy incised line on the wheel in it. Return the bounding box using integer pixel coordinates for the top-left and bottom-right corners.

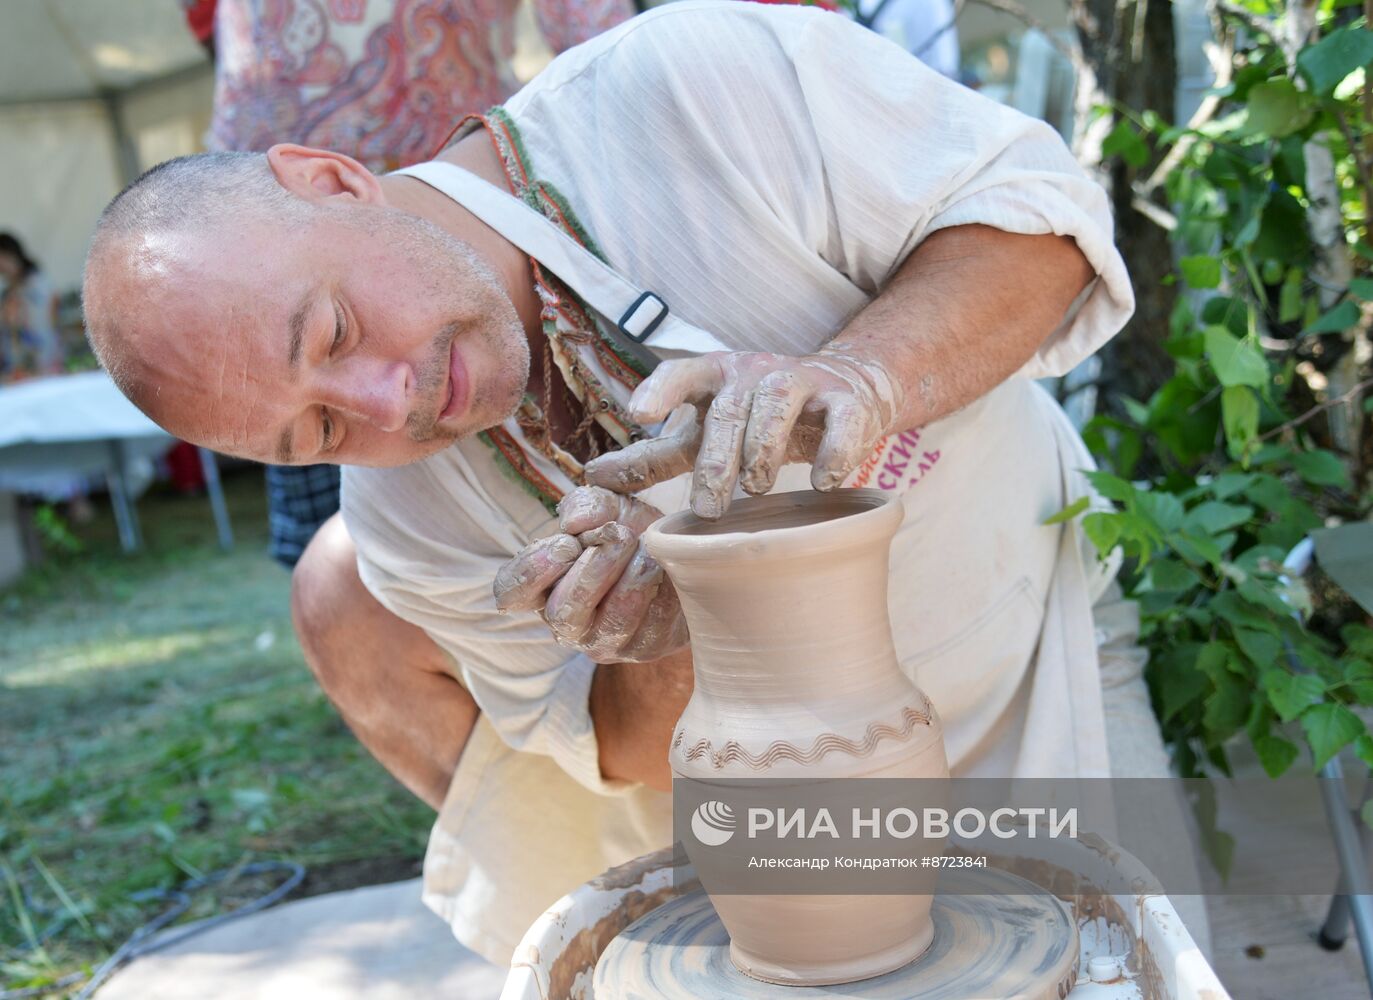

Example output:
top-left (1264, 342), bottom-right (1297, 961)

top-left (645, 489), bottom-right (949, 985)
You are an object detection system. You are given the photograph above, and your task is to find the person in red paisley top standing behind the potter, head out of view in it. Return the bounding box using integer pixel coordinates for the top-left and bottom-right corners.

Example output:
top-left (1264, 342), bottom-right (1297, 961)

top-left (183, 0), bottom-right (634, 567)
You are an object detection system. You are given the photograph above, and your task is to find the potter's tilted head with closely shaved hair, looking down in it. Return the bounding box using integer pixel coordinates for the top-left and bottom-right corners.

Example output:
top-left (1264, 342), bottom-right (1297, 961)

top-left (76, 144), bottom-right (529, 466)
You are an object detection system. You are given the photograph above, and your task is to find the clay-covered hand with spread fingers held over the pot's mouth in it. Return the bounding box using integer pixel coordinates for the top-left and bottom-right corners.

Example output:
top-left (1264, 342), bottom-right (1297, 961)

top-left (586, 345), bottom-right (902, 519)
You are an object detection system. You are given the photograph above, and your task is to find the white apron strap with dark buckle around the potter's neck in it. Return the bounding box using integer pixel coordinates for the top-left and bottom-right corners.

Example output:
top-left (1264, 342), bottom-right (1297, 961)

top-left (391, 159), bottom-right (729, 368)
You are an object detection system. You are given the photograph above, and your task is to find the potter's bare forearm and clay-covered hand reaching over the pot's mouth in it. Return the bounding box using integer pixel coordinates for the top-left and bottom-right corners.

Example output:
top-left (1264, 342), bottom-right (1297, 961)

top-left (586, 224), bottom-right (1093, 519)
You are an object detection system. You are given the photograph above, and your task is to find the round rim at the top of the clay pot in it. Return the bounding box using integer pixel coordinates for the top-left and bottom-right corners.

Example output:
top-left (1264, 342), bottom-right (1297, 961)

top-left (644, 489), bottom-right (905, 560)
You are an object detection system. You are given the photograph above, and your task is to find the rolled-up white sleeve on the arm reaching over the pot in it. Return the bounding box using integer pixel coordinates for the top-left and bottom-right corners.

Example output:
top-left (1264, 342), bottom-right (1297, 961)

top-left (791, 15), bottom-right (1134, 378)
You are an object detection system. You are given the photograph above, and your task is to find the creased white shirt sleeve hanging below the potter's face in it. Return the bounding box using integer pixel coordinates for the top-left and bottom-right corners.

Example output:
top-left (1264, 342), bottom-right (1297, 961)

top-left (342, 458), bottom-right (634, 795)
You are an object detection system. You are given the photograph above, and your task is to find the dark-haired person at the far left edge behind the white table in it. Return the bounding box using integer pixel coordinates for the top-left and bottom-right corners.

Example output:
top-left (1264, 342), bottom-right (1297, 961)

top-left (0, 232), bottom-right (62, 378)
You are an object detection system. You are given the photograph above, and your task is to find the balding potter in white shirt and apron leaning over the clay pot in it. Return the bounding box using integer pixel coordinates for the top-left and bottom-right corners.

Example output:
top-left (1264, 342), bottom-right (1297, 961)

top-left (85, 3), bottom-right (1142, 962)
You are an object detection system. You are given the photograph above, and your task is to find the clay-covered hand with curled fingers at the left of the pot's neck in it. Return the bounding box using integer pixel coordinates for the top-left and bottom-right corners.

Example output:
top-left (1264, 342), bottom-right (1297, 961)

top-left (494, 486), bottom-right (688, 663)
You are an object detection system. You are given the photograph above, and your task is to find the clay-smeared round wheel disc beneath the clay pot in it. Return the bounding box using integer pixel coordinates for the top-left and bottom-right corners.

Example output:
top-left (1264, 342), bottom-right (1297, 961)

top-left (593, 868), bottom-right (1078, 1000)
